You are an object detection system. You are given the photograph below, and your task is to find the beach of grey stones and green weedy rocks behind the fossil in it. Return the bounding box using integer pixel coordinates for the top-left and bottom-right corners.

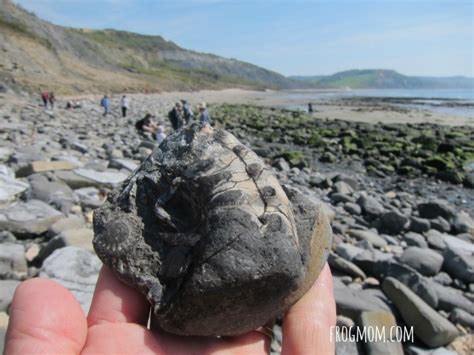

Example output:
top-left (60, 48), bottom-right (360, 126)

top-left (0, 96), bottom-right (474, 354)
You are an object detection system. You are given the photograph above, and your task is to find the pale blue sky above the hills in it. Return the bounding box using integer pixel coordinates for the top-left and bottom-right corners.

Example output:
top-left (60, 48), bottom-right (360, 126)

top-left (15, 0), bottom-right (474, 76)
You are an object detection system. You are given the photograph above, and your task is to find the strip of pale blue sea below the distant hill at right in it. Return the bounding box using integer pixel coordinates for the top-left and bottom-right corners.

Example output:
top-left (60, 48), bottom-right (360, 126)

top-left (281, 88), bottom-right (474, 119)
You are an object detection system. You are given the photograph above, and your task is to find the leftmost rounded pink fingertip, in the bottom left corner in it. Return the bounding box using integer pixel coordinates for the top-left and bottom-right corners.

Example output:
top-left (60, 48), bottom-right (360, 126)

top-left (5, 278), bottom-right (87, 354)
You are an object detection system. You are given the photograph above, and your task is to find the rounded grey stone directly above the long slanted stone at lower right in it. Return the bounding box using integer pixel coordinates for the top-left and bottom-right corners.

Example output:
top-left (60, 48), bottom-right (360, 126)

top-left (399, 247), bottom-right (444, 276)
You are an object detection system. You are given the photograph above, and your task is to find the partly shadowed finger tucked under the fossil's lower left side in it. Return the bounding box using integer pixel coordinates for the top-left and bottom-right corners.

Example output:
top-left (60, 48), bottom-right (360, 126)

top-left (87, 266), bottom-right (150, 327)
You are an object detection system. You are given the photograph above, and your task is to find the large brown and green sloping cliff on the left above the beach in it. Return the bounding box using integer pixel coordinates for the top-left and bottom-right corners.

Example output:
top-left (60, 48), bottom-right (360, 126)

top-left (0, 0), bottom-right (294, 93)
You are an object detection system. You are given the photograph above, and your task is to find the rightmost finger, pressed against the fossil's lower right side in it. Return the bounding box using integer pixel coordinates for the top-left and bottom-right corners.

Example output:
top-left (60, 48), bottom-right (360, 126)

top-left (282, 264), bottom-right (336, 355)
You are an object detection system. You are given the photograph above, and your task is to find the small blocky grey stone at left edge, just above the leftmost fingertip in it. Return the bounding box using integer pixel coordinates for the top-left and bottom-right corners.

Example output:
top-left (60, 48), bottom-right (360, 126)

top-left (0, 243), bottom-right (28, 278)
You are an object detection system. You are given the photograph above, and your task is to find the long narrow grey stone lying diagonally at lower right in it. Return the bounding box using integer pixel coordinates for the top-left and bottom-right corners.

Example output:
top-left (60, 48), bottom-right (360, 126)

top-left (382, 277), bottom-right (458, 348)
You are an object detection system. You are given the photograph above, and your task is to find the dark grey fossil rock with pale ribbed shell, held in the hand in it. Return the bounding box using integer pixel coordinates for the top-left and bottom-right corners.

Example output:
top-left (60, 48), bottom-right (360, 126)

top-left (94, 125), bottom-right (332, 336)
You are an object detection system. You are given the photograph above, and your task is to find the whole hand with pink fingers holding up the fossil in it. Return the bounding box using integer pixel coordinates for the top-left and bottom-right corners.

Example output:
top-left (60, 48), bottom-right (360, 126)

top-left (5, 265), bottom-right (336, 355)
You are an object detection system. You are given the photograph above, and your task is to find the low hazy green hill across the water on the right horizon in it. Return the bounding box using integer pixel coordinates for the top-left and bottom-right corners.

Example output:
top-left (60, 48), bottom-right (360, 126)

top-left (290, 69), bottom-right (474, 89)
